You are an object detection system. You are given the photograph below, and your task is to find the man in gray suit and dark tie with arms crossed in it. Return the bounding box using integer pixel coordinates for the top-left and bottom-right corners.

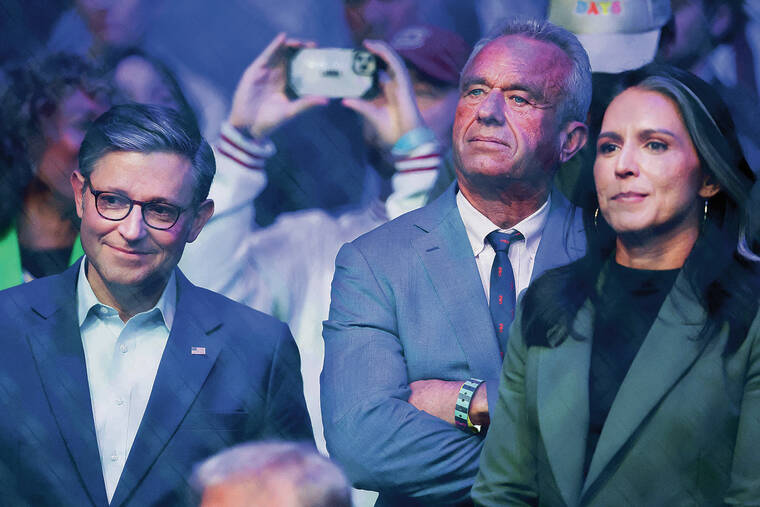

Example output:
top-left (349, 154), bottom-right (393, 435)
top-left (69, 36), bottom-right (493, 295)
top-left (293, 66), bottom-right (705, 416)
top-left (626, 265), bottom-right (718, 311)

top-left (321, 17), bottom-right (591, 505)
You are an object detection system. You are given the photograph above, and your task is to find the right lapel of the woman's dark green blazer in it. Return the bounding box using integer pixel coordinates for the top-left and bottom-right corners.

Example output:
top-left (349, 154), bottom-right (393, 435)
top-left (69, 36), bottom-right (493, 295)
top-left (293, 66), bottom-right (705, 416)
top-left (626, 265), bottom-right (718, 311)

top-left (583, 273), bottom-right (708, 494)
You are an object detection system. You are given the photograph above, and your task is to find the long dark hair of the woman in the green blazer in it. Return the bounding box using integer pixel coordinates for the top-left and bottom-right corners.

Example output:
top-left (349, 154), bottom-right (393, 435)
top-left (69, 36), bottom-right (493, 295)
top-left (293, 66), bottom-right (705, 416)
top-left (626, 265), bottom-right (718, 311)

top-left (522, 65), bottom-right (760, 353)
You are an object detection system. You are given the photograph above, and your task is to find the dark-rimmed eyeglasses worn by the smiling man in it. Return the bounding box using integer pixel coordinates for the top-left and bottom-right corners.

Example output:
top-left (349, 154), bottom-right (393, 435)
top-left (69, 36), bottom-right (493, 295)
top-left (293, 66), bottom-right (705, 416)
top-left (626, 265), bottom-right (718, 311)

top-left (87, 178), bottom-right (188, 231)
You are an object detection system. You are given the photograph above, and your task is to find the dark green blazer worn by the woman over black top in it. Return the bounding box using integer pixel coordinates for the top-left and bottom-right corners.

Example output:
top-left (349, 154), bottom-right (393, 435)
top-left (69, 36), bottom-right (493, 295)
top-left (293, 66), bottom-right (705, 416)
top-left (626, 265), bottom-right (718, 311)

top-left (472, 268), bottom-right (760, 506)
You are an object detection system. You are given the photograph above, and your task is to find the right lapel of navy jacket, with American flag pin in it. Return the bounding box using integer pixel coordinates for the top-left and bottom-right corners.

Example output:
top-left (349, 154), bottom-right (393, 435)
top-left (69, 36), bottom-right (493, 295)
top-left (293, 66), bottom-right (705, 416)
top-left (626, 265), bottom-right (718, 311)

top-left (111, 270), bottom-right (223, 506)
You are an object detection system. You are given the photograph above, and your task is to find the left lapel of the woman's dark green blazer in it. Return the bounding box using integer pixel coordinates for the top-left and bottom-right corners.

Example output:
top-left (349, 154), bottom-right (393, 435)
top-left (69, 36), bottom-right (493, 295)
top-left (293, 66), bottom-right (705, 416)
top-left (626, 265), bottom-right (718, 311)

top-left (536, 301), bottom-right (594, 506)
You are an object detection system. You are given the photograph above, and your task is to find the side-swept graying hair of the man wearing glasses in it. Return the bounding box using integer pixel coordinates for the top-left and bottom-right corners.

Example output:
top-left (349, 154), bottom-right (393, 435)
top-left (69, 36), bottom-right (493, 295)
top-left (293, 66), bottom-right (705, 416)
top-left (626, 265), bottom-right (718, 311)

top-left (79, 104), bottom-right (216, 204)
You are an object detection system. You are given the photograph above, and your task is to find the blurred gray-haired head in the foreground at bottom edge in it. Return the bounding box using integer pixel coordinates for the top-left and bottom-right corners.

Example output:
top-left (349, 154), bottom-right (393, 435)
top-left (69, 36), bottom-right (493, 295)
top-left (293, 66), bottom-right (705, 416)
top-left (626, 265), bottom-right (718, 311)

top-left (191, 442), bottom-right (351, 507)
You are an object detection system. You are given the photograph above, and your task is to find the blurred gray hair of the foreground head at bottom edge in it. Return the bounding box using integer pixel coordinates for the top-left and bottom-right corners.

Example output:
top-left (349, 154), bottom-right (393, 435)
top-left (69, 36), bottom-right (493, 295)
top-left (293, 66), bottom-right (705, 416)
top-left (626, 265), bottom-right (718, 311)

top-left (190, 442), bottom-right (351, 507)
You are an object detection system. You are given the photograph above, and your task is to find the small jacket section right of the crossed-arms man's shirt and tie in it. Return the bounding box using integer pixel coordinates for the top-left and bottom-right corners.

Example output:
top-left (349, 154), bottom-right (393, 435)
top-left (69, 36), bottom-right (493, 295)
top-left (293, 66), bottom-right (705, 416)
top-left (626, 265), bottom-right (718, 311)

top-left (531, 191), bottom-right (586, 282)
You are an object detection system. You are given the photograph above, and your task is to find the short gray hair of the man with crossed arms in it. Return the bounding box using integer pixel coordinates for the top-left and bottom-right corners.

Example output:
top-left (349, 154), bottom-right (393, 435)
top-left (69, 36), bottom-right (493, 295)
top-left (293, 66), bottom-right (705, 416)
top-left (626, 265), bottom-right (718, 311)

top-left (462, 18), bottom-right (591, 125)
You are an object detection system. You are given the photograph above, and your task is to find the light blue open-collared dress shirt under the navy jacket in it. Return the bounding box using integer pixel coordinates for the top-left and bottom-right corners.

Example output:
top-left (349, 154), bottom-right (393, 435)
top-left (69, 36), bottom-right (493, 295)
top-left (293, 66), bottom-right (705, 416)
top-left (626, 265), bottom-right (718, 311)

top-left (77, 258), bottom-right (177, 502)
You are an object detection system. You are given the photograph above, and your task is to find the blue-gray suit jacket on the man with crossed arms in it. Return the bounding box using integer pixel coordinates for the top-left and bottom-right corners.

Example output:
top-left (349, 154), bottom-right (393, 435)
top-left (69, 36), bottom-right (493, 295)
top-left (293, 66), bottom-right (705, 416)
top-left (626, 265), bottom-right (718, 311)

top-left (321, 185), bottom-right (585, 505)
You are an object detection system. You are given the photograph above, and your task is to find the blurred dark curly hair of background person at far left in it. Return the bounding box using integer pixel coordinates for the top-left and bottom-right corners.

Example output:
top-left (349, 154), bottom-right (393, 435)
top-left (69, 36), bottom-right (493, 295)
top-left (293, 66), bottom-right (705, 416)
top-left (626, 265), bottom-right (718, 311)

top-left (0, 53), bottom-right (110, 231)
